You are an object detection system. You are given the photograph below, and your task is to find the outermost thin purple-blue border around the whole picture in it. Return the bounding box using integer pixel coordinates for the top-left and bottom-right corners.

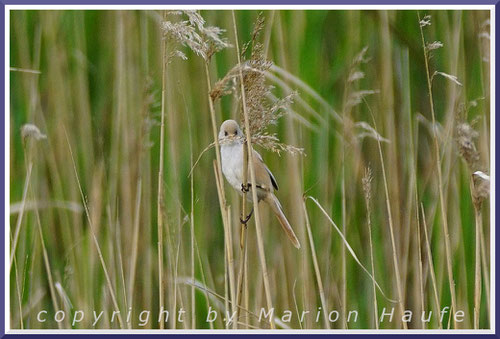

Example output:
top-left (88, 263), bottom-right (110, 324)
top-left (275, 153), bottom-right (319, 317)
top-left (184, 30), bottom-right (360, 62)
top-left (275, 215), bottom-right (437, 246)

top-left (0, 0), bottom-right (500, 339)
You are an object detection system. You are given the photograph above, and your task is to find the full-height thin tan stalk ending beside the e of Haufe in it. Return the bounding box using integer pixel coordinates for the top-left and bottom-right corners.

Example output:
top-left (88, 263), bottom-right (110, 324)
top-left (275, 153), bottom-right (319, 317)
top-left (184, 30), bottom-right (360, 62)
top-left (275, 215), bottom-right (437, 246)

top-left (418, 13), bottom-right (457, 328)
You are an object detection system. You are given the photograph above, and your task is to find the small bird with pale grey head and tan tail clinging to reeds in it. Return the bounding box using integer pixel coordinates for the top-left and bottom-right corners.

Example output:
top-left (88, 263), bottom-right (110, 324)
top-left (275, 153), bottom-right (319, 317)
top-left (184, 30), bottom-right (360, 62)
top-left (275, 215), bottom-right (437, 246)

top-left (219, 120), bottom-right (300, 248)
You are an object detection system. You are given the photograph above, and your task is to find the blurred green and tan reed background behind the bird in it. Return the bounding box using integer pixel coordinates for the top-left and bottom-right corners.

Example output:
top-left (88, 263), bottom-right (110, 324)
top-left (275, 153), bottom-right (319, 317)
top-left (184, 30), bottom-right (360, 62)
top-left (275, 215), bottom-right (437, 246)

top-left (10, 10), bottom-right (491, 329)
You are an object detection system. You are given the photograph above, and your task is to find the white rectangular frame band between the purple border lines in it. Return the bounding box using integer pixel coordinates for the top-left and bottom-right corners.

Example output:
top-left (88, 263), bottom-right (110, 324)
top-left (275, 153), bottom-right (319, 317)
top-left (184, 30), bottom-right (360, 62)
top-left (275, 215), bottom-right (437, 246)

top-left (4, 5), bottom-right (496, 335)
